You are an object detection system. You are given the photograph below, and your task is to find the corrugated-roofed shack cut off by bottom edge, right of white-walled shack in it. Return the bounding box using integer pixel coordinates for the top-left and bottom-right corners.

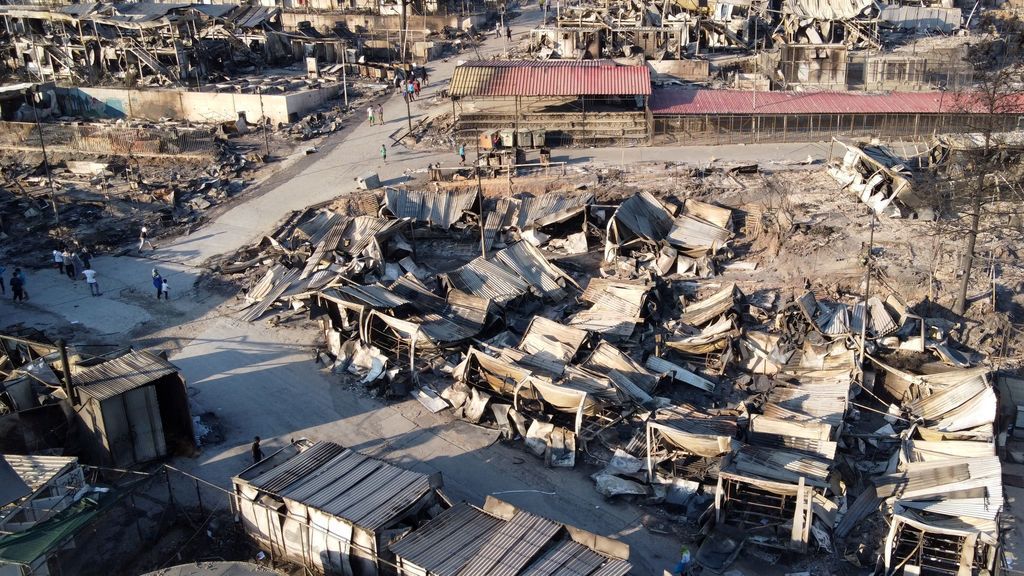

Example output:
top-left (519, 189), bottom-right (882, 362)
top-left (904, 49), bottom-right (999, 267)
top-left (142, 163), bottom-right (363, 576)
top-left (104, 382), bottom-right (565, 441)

top-left (390, 496), bottom-right (632, 576)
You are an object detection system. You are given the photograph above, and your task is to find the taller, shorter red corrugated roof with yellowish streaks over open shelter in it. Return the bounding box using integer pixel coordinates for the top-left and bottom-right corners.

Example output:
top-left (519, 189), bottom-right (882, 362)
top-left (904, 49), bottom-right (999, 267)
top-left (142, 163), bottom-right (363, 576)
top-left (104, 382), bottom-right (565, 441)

top-left (449, 60), bottom-right (650, 96)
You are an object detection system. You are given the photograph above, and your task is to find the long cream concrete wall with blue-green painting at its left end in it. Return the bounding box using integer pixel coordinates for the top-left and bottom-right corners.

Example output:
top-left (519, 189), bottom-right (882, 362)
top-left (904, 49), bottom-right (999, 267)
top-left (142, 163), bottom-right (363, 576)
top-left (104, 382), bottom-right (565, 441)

top-left (57, 86), bottom-right (341, 123)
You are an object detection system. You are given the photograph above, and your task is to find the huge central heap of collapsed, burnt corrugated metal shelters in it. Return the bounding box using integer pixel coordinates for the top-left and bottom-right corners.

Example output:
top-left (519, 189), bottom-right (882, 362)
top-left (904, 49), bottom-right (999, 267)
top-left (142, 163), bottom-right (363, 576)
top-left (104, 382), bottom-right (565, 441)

top-left (220, 177), bottom-right (1007, 574)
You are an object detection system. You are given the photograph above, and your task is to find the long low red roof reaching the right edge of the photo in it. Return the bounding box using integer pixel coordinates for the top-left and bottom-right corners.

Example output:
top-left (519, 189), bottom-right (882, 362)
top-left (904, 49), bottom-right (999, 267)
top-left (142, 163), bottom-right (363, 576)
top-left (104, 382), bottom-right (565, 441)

top-left (650, 88), bottom-right (1024, 115)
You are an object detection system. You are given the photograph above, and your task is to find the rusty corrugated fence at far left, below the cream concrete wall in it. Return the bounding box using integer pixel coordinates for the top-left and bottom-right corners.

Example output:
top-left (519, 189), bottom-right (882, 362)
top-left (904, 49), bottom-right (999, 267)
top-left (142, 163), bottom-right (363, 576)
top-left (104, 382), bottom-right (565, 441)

top-left (0, 122), bottom-right (217, 158)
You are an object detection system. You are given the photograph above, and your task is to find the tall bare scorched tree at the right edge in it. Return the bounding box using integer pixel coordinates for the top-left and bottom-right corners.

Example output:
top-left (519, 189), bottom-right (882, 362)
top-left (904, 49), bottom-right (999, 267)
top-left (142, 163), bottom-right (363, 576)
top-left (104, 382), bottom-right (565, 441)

top-left (937, 50), bottom-right (1024, 315)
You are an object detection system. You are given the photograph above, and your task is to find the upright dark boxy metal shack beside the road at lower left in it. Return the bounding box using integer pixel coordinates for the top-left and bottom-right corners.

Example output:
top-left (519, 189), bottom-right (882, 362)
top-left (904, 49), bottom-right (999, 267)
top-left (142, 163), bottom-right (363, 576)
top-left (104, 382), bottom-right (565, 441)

top-left (72, 352), bottom-right (196, 467)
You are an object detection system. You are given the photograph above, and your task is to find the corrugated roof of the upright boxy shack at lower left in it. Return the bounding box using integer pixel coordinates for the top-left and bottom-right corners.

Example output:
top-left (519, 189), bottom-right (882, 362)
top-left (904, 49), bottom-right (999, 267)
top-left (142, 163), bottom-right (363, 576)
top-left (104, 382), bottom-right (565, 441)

top-left (72, 351), bottom-right (178, 401)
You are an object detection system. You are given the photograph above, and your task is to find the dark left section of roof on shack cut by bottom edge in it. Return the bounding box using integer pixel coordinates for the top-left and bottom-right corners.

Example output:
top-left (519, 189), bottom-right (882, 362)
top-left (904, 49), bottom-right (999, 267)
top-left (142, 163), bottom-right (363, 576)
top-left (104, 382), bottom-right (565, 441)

top-left (390, 502), bottom-right (504, 576)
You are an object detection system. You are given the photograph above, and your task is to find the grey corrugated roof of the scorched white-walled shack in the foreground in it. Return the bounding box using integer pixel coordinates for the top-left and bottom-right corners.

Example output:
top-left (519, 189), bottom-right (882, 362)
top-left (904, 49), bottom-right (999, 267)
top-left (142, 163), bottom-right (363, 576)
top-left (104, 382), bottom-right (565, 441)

top-left (250, 442), bottom-right (440, 531)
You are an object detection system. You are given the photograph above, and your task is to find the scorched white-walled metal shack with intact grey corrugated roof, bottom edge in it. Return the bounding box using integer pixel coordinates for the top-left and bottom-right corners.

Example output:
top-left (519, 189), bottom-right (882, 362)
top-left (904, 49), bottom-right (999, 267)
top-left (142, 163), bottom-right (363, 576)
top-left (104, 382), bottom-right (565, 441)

top-left (231, 442), bottom-right (451, 576)
